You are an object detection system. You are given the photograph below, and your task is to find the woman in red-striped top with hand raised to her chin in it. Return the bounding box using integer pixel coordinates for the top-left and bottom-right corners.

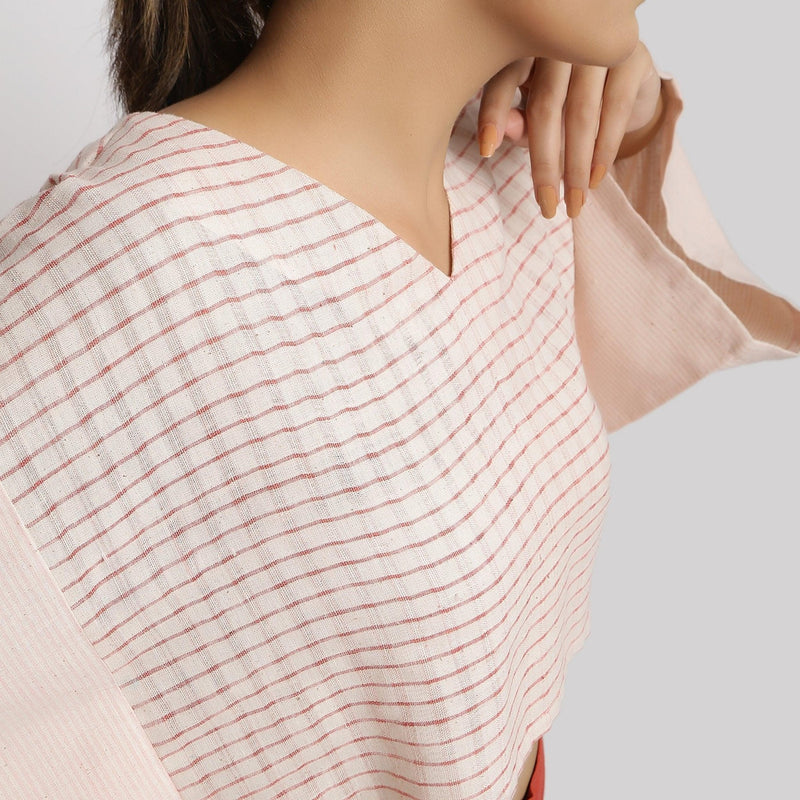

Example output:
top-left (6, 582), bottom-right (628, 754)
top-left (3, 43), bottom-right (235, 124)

top-left (0, 0), bottom-right (800, 798)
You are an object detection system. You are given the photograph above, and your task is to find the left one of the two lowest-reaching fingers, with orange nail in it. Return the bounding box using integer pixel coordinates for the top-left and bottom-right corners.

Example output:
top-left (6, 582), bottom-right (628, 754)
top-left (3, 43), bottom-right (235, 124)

top-left (525, 59), bottom-right (572, 219)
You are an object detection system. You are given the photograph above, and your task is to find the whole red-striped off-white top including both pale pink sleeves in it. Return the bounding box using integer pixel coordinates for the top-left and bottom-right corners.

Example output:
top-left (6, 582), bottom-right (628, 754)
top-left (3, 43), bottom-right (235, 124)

top-left (0, 75), bottom-right (800, 800)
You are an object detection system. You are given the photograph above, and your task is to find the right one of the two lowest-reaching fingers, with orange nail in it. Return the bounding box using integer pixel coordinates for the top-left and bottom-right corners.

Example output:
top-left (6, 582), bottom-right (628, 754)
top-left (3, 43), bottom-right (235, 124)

top-left (564, 66), bottom-right (610, 218)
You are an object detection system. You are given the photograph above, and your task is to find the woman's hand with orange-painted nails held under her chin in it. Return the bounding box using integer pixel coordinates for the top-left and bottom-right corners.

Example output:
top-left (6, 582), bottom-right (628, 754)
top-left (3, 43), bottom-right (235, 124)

top-left (478, 42), bottom-right (663, 219)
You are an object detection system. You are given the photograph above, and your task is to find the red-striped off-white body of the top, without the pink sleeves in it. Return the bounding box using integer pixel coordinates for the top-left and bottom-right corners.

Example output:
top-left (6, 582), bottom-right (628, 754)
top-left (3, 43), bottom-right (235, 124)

top-left (0, 98), bottom-right (610, 800)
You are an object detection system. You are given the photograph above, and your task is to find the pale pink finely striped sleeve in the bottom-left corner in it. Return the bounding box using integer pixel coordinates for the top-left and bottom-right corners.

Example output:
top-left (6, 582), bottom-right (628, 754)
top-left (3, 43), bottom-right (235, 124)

top-left (0, 484), bottom-right (180, 800)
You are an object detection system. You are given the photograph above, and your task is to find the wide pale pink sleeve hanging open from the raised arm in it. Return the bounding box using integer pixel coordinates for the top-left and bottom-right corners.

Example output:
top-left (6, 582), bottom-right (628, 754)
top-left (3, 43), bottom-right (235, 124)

top-left (573, 73), bottom-right (800, 432)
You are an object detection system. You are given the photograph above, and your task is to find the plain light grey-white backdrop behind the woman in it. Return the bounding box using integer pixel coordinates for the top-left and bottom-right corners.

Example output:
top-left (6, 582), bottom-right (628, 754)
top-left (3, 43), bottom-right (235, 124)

top-left (0, 0), bottom-right (800, 800)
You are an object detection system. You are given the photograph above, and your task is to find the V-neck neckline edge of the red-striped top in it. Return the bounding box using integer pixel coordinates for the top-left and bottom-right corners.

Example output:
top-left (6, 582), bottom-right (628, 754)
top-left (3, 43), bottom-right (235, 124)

top-left (120, 111), bottom-right (465, 283)
